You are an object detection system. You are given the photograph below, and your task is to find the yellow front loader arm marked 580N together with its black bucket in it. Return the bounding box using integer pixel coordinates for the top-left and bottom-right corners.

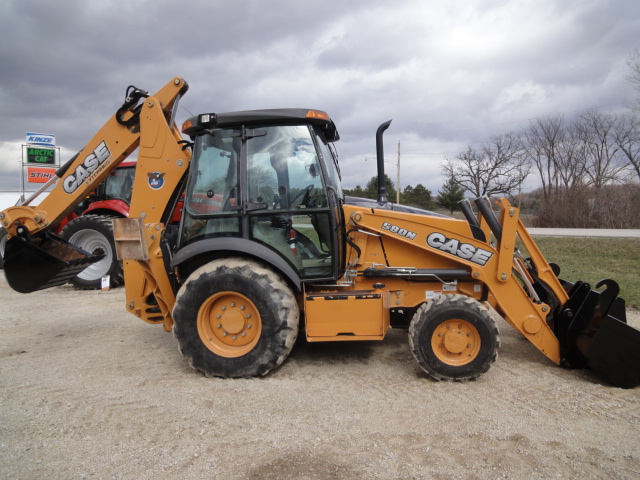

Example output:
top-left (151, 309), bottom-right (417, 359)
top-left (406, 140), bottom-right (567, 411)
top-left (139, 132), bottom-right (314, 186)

top-left (345, 198), bottom-right (640, 388)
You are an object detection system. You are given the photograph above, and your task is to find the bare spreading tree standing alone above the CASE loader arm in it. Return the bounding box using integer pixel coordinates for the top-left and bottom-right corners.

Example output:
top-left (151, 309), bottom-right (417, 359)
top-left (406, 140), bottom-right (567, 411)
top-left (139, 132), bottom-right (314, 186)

top-left (442, 133), bottom-right (529, 197)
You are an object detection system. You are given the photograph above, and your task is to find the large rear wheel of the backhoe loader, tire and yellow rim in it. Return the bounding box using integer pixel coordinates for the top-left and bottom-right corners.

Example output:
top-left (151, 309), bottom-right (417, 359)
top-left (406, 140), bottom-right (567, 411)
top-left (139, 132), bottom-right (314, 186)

top-left (173, 258), bottom-right (300, 378)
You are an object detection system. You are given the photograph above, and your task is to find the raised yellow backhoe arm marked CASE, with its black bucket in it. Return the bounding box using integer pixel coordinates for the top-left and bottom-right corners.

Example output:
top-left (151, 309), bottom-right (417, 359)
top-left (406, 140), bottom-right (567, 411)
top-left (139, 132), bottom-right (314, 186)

top-left (0, 77), bottom-right (190, 293)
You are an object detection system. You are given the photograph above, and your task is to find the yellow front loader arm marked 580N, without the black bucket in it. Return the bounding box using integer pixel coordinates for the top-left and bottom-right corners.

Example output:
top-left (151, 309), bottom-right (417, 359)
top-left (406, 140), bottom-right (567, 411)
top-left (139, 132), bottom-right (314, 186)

top-left (350, 204), bottom-right (561, 364)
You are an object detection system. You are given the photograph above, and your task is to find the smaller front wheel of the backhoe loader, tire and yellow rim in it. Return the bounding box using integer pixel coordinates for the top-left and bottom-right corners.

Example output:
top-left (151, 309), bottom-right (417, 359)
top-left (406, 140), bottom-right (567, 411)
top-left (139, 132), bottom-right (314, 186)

top-left (409, 295), bottom-right (500, 382)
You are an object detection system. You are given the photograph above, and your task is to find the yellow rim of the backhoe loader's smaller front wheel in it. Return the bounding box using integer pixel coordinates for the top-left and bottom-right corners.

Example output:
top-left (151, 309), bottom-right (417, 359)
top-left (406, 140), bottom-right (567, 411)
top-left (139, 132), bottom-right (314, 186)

top-left (431, 319), bottom-right (481, 366)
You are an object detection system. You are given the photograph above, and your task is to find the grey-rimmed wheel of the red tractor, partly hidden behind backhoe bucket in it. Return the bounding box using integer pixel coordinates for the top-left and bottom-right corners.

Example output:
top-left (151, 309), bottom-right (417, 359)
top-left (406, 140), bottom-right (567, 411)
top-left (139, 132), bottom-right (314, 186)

top-left (60, 215), bottom-right (124, 290)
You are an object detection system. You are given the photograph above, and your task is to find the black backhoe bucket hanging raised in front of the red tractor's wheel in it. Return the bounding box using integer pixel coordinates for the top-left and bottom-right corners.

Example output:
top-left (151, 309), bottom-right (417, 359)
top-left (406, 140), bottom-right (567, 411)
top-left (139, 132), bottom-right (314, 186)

top-left (4, 233), bottom-right (104, 293)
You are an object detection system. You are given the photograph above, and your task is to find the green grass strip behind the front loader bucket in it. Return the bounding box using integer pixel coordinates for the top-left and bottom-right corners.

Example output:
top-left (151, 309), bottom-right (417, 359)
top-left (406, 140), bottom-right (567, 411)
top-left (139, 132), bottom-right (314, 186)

top-left (534, 237), bottom-right (640, 308)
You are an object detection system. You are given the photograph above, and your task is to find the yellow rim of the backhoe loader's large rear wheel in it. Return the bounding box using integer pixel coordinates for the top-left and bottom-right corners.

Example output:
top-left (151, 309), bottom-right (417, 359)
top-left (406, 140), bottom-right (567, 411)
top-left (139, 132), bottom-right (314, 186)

top-left (198, 292), bottom-right (262, 358)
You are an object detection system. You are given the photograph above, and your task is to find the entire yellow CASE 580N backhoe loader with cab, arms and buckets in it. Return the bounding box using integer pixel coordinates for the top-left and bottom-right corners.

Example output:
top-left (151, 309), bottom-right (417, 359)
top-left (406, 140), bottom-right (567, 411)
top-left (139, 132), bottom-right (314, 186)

top-left (0, 77), bottom-right (640, 388)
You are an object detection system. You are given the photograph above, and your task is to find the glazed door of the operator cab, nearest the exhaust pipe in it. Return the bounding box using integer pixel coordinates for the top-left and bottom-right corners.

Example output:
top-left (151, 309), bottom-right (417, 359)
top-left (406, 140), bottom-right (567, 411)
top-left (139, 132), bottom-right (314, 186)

top-left (246, 125), bottom-right (337, 280)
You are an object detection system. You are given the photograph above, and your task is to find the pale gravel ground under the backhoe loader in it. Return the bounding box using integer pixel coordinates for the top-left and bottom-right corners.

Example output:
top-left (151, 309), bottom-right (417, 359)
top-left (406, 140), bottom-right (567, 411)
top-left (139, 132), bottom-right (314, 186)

top-left (0, 278), bottom-right (640, 479)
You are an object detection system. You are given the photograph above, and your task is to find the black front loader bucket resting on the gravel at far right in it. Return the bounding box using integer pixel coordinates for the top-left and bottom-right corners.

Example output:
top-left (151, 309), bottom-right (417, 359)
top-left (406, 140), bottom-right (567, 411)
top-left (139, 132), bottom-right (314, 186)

top-left (555, 280), bottom-right (640, 388)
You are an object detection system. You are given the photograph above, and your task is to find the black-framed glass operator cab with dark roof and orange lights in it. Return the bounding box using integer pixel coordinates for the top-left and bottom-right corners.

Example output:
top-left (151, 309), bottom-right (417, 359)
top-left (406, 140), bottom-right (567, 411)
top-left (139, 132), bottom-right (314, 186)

top-left (179, 109), bottom-right (344, 281)
